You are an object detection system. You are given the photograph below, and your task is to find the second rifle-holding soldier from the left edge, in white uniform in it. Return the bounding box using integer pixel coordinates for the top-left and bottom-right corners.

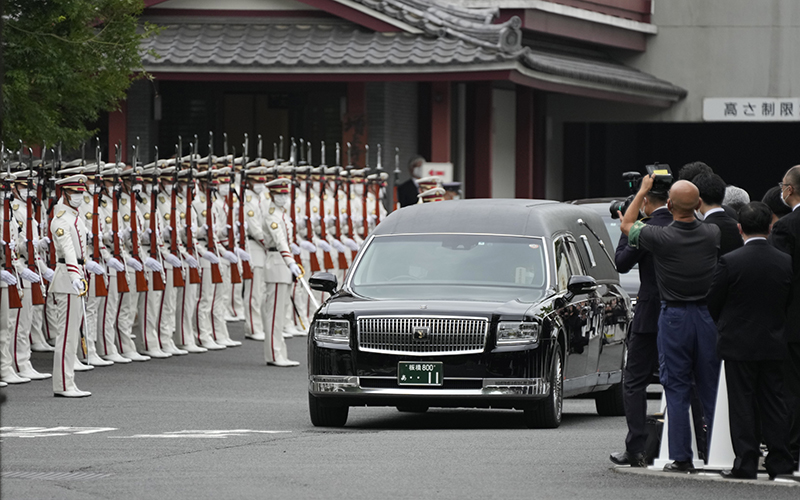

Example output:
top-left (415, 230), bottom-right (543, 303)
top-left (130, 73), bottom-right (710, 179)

top-left (9, 170), bottom-right (52, 380)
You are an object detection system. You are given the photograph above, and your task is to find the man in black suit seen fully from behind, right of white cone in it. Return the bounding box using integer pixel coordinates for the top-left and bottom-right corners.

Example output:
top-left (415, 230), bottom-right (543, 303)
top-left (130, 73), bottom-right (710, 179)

top-left (708, 201), bottom-right (793, 479)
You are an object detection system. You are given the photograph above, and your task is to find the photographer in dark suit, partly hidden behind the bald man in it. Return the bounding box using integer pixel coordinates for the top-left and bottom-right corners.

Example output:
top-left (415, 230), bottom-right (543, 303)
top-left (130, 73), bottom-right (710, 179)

top-left (610, 186), bottom-right (672, 467)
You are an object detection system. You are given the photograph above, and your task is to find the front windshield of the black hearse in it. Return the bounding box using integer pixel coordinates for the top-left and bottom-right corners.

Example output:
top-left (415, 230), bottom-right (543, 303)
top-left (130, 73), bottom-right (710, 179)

top-left (350, 234), bottom-right (548, 301)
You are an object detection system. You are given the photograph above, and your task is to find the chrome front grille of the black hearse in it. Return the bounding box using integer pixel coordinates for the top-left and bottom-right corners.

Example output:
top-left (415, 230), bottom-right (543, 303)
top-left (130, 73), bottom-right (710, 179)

top-left (358, 316), bottom-right (489, 356)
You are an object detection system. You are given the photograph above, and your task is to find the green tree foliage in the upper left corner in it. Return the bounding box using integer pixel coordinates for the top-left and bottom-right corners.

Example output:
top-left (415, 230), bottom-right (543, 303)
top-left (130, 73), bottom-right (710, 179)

top-left (2, 0), bottom-right (156, 147)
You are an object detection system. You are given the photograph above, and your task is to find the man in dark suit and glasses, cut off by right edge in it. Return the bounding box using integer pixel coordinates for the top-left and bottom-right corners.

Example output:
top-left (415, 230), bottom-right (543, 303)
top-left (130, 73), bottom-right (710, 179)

top-left (769, 165), bottom-right (800, 468)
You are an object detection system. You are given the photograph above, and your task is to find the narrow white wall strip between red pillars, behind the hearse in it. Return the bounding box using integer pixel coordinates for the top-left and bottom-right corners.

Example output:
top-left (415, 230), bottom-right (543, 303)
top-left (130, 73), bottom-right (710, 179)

top-left (490, 89), bottom-right (517, 198)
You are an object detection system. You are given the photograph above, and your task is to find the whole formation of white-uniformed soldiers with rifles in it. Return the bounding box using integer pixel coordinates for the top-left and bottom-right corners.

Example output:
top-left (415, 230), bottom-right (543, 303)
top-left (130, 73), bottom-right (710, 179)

top-left (0, 135), bottom-right (444, 397)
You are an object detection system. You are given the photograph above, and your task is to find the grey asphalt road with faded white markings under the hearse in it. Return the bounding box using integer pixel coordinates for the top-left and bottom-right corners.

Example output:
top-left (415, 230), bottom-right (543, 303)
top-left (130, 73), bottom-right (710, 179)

top-left (0, 323), bottom-right (800, 500)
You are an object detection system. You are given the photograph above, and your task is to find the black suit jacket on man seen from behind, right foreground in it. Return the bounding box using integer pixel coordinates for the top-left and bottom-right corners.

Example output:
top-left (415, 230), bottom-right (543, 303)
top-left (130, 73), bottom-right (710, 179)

top-left (708, 240), bottom-right (792, 361)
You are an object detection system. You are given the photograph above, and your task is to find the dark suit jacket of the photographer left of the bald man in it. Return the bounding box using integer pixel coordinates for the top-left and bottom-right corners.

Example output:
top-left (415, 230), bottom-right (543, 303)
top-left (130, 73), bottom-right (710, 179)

top-left (614, 209), bottom-right (672, 333)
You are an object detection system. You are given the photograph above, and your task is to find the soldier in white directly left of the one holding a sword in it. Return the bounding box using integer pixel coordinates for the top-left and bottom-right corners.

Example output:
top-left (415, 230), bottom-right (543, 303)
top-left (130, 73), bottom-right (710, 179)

top-left (244, 161), bottom-right (275, 341)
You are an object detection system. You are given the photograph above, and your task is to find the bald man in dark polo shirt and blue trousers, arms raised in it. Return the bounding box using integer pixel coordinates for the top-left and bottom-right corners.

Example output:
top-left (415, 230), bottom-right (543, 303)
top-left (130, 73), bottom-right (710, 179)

top-left (620, 175), bottom-right (720, 473)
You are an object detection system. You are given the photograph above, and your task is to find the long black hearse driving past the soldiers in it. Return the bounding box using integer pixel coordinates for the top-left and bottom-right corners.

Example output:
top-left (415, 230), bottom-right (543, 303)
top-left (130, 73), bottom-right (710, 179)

top-left (308, 199), bottom-right (631, 428)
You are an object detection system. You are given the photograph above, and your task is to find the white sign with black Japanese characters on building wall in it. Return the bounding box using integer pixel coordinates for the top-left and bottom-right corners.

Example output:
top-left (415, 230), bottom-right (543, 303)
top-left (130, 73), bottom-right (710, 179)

top-left (703, 97), bottom-right (800, 122)
